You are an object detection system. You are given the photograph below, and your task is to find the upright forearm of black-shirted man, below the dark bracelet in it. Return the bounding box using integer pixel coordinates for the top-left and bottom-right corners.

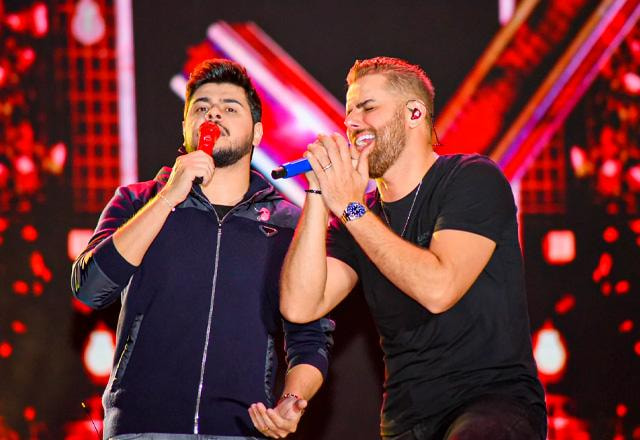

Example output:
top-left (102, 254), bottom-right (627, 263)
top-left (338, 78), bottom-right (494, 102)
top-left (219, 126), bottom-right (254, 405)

top-left (280, 194), bottom-right (328, 322)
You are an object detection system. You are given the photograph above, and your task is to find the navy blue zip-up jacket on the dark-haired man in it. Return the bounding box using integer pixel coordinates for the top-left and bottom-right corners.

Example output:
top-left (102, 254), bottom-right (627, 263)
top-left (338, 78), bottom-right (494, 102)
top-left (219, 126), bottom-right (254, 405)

top-left (71, 167), bottom-right (334, 438)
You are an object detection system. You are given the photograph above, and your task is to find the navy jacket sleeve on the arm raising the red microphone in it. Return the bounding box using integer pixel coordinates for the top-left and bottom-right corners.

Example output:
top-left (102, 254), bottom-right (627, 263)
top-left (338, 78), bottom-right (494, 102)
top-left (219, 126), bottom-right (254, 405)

top-left (71, 184), bottom-right (150, 309)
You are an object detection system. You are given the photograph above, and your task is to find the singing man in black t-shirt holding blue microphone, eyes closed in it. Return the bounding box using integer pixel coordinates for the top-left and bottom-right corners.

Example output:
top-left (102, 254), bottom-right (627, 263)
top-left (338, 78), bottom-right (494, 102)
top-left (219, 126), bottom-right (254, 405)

top-left (280, 57), bottom-right (546, 440)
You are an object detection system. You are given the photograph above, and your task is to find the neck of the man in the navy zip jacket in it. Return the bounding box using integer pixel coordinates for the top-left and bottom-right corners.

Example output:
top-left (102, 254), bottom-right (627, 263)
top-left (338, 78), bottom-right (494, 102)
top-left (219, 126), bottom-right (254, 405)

top-left (200, 159), bottom-right (250, 206)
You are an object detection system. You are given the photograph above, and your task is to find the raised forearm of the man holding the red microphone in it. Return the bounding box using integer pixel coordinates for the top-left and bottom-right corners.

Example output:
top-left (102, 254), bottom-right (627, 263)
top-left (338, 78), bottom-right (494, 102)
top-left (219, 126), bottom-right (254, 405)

top-left (113, 192), bottom-right (172, 266)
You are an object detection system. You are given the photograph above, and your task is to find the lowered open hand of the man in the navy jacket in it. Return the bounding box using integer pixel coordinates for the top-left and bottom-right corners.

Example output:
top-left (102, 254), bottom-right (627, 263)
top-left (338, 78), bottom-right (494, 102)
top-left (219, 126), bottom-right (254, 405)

top-left (249, 396), bottom-right (307, 438)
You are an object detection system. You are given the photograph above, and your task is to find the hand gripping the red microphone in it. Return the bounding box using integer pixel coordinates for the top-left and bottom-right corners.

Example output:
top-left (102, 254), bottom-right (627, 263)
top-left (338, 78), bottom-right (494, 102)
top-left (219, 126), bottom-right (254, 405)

top-left (161, 150), bottom-right (215, 206)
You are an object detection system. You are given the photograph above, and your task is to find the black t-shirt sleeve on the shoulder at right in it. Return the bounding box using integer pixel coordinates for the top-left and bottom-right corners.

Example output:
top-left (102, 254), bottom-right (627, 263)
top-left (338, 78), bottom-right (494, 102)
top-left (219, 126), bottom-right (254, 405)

top-left (434, 156), bottom-right (516, 242)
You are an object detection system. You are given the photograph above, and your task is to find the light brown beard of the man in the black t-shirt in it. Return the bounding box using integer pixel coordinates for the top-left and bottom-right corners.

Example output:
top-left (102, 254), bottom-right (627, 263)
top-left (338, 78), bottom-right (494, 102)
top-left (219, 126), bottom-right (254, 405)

top-left (369, 106), bottom-right (407, 179)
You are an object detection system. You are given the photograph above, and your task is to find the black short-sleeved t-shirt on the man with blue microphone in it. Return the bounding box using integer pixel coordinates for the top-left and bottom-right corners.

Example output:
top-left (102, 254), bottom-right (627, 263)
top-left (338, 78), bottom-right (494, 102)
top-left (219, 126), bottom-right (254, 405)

top-left (327, 155), bottom-right (545, 435)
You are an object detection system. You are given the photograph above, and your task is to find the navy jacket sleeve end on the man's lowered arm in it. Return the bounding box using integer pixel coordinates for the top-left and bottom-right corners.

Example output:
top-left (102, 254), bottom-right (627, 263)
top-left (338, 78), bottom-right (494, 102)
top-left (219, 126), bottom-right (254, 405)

top-left (283, 318), bottom-right (336, 379)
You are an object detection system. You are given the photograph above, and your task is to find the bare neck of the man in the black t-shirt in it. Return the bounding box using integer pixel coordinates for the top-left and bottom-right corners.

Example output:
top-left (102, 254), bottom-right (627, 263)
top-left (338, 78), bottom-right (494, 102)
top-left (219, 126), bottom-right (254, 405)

top-left (376, 144), bottom-right (438, 202)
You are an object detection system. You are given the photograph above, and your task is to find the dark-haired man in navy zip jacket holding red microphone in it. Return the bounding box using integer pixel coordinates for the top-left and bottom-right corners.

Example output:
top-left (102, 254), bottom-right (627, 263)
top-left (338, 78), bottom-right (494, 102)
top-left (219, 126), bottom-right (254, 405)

top-left (72, 59), bottom-right (333, 440)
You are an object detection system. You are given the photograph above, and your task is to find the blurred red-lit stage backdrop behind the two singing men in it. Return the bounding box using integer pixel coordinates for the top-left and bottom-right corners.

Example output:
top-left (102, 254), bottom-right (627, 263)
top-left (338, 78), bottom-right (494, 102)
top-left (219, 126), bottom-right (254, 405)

top-left (0, 0), bottom-right (640, 440)
